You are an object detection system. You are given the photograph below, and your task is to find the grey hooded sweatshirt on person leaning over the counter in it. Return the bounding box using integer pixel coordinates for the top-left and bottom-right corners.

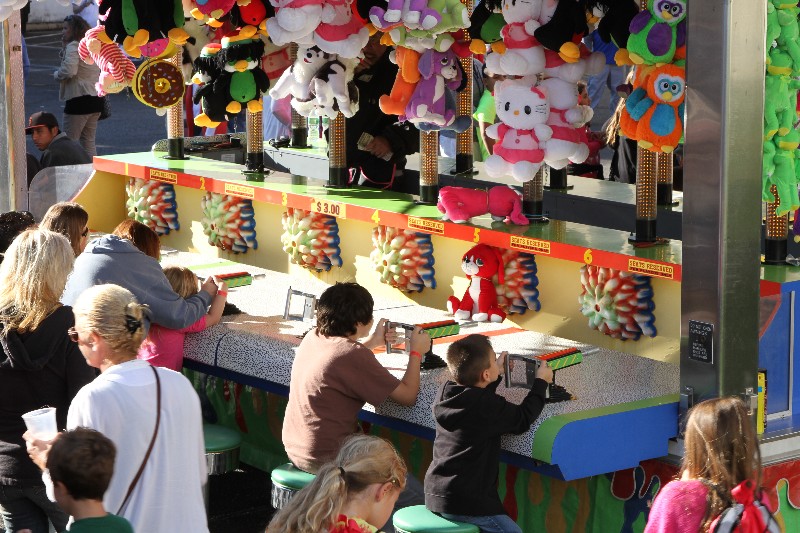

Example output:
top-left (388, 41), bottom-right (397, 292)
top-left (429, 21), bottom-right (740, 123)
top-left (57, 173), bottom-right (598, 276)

top-left (61, 235), bottom-right (211, 329)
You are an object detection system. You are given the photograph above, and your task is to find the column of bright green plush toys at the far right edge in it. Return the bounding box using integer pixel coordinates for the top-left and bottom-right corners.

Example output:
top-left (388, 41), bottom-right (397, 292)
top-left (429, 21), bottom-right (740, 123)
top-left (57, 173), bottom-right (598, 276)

top-left (761, 0), bottom-right (800, 217)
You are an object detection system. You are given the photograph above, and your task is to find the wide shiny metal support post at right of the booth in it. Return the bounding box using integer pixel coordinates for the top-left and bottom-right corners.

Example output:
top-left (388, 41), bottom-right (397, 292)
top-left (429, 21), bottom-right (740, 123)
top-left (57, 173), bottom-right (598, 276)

top-left (680, 0), bottom-right (766, 412)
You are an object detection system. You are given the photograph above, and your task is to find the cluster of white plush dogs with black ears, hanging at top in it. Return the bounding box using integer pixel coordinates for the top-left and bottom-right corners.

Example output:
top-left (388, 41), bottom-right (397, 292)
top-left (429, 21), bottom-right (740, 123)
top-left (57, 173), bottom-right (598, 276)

top-left (269, 46), bottom-right (358, 119)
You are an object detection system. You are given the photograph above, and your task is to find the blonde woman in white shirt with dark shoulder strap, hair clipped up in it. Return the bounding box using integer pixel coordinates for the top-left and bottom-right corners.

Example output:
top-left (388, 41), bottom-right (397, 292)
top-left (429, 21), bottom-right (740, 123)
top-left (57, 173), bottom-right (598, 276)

top-left (26, 285), bottom-right (208, 533)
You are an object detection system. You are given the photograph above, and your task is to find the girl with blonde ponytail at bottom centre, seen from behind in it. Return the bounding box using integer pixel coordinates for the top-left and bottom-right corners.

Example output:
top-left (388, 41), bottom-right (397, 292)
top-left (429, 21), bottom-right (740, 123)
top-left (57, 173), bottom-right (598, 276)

top-left (267, 435), bottom-right (406, 533)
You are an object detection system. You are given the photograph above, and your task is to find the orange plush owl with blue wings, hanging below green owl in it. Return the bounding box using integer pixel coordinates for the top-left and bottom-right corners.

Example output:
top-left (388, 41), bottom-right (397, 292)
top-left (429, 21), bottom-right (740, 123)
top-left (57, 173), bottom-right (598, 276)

top-left (620, 65), bottom-right (686, 153)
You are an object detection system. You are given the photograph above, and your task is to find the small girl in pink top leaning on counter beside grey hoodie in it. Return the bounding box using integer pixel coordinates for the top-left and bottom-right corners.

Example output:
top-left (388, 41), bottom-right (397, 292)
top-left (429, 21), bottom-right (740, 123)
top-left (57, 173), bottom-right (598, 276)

top-left (138, 265), bottom-right (228, 372)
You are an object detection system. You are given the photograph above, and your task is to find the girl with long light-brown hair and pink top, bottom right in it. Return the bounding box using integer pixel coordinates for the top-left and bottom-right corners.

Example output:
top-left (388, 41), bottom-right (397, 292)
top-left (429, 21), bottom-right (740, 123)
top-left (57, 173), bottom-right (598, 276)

top-left (645, 397), bottom-right (761, 533)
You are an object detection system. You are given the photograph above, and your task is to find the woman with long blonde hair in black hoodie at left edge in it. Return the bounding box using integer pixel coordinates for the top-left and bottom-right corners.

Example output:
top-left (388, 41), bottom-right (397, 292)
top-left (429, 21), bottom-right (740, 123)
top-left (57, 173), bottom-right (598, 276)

top-left (0, 229), bottom-right (96, 533)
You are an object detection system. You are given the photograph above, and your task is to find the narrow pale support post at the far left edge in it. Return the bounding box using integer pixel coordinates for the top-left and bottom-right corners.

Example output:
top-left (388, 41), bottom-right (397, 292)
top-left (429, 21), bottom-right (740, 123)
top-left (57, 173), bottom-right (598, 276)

top-left (0, 10), bottom-right (28, 212)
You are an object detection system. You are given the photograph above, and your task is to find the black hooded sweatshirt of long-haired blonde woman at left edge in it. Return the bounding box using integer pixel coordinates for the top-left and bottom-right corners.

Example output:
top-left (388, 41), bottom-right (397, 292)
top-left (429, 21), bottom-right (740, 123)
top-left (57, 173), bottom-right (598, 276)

top-left (0, 306), bottom-right (97, 487)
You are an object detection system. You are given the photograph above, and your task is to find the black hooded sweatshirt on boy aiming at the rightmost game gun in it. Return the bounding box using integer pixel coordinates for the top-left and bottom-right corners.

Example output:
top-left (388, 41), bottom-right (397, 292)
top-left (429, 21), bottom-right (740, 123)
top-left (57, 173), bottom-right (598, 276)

top-left (425, 378), bottom-right (547, 516)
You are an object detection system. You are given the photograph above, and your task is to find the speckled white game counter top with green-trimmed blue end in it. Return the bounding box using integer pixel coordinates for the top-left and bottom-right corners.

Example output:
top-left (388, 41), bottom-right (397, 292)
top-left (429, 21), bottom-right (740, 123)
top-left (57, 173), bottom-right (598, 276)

top-left (170, 252), bottom-right (679, 479)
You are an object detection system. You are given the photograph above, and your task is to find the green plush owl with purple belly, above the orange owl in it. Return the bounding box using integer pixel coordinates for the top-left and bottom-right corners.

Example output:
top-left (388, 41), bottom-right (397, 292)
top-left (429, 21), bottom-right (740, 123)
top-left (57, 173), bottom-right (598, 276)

top-left (627, 0), bottom-right (686, 65)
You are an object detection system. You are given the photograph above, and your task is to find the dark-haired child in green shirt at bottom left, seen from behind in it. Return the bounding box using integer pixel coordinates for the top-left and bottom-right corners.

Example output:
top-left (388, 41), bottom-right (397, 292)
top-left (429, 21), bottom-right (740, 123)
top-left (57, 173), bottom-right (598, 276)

top-left (47, 427), bottom-right (133, 533)
